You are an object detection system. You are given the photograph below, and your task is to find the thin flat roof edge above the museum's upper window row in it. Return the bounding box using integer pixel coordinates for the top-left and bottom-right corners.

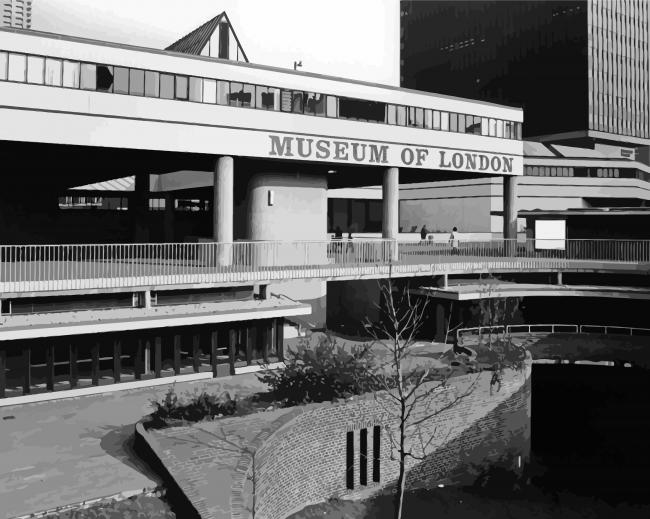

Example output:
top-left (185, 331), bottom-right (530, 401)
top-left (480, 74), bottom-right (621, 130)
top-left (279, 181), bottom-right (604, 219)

top-left (0, 27), bottom-right (523, 112)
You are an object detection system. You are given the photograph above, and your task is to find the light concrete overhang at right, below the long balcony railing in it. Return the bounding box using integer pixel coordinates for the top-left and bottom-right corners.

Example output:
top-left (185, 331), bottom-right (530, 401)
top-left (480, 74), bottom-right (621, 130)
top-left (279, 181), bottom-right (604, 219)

top-left (411, 283), bottom-right (650, 301)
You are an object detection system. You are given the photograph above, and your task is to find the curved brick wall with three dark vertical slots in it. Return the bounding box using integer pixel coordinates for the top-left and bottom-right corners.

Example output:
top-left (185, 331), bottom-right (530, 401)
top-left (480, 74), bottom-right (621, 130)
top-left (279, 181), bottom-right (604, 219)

top-left (251, 362), bottom-right (531, 519)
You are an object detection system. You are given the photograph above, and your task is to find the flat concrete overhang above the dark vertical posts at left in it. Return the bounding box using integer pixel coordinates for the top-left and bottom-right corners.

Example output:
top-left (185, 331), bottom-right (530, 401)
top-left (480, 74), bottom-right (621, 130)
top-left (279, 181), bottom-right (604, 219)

top-left (0, 298), bottom-right (312, 341)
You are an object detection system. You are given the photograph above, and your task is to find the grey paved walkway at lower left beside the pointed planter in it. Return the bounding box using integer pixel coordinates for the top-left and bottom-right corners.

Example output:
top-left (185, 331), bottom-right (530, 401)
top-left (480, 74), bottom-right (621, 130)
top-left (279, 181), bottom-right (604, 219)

top-left (0, 374), bottom-right (265, 519)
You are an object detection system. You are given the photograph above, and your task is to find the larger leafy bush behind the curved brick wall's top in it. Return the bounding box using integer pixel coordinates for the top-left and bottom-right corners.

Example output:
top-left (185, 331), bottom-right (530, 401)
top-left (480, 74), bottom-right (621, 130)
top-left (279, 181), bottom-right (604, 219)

top-left (258, 336), bottom-right (375, 405)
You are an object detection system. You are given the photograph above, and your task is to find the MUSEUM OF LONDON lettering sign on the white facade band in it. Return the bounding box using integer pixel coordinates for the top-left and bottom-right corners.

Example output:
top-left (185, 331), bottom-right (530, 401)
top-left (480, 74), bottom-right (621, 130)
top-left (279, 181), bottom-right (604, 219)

top-left (269, 135), bottom-right (514, 174)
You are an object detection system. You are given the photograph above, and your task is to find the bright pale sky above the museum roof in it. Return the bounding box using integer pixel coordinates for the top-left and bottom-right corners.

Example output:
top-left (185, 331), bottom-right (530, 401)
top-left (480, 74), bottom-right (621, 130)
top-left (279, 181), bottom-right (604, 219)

top-left (32, 0), bottom-right (399, 85)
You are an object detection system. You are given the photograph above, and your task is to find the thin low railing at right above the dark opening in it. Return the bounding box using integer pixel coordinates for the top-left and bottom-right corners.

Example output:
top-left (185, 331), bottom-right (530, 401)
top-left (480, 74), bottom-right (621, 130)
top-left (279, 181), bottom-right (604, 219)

top-left (456, 323), bottom-right (650, 340)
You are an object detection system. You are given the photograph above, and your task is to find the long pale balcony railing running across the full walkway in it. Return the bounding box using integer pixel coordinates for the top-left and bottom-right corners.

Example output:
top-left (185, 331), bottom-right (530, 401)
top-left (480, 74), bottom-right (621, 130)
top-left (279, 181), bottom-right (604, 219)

top-left (0, 239), bottom-right (650, 295)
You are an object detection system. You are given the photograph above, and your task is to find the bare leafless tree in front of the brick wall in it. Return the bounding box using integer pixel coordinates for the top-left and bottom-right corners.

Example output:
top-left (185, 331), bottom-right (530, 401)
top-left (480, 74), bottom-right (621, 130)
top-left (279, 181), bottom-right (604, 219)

top-left (366, 278), bottom-right (478, 519)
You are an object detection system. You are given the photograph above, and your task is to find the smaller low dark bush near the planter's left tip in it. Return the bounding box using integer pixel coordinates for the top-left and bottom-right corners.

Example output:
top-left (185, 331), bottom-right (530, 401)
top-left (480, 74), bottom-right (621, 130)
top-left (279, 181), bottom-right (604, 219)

top-left (151, 386), bottom-right (237, 424)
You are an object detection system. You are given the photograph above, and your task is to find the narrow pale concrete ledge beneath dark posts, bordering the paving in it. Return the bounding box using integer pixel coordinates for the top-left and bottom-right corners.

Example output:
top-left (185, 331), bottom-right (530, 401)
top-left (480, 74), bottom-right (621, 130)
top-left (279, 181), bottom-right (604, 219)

top-left (0, 371), bottom-right (213, 407)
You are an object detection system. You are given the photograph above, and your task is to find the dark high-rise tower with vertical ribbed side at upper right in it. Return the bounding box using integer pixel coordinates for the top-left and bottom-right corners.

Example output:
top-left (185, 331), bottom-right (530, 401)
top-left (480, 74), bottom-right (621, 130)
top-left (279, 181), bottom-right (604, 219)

top-left (401, 0), bottom-right (650, 145)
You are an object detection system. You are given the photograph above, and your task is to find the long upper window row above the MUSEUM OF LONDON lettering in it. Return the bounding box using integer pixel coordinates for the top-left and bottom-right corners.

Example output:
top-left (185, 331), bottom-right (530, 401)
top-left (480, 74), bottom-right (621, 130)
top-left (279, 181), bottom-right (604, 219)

top-left (0, 52), bottom-right (522, 140)
